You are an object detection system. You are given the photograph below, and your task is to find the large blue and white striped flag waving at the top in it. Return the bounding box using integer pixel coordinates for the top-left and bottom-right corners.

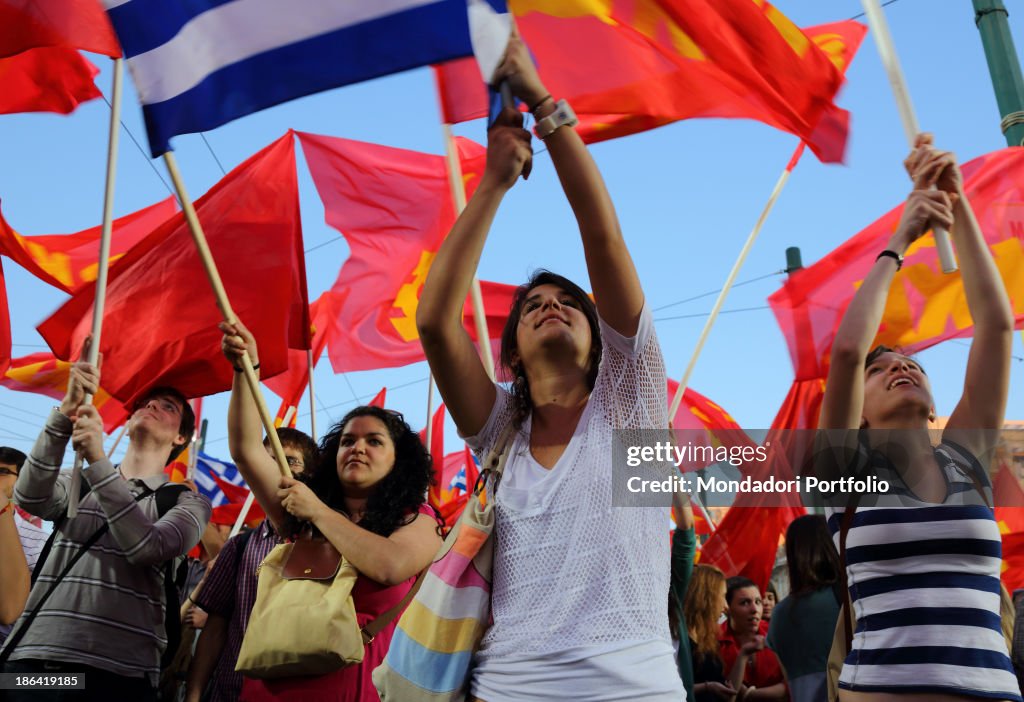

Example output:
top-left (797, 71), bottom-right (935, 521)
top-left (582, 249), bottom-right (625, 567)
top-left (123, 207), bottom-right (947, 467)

top-left (102, 0), bottom-right (509, 158)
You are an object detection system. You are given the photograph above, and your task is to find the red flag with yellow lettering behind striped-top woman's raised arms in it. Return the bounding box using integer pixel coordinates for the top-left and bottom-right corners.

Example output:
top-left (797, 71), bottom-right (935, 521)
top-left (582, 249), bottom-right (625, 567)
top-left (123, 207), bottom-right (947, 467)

top-left (768, 147), bottom-right (1024, 380)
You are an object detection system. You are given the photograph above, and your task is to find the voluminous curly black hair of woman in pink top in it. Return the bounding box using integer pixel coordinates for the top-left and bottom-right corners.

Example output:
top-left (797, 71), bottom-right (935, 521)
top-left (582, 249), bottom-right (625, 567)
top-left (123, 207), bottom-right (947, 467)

top-left (290, 405), bottom-right (436, 536)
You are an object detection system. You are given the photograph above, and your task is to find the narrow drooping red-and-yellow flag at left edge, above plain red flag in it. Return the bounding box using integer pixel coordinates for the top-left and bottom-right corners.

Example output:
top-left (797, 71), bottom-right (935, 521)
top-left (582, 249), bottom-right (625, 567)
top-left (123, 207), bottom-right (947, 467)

top-left (0, 198), bottom-right (177, 293)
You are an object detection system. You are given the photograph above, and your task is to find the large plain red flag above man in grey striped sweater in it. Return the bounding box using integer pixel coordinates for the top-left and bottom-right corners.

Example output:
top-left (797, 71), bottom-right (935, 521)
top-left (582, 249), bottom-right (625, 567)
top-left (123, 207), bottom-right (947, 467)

top-left (38, 133), bottom-right (309, 404)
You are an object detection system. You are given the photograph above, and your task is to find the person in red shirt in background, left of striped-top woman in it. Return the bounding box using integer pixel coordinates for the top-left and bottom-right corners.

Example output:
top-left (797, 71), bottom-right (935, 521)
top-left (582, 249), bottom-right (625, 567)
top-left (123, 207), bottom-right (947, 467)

top-left (718, 576), bottom-right (790, 702)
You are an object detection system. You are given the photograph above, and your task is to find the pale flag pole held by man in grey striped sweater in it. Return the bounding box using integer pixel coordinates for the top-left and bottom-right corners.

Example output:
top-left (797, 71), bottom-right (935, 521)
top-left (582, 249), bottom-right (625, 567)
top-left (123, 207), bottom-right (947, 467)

top-left (68, 58), bottom-right (127, 519)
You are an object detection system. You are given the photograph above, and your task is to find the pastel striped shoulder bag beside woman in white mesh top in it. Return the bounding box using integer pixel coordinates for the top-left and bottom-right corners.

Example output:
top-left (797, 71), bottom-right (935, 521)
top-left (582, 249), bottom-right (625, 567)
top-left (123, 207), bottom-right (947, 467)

top-left (373, 426), bottom-right (514, 702)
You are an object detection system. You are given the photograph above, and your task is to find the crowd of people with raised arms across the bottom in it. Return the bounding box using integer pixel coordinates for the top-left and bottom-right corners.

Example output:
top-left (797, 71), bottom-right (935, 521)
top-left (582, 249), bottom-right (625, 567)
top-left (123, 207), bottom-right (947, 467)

top-left (0, 36), bottom-right (1024, 702)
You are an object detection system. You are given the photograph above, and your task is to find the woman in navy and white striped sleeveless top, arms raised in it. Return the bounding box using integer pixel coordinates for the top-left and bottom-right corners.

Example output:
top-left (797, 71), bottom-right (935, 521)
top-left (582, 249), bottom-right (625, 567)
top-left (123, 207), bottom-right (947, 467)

top-left (820, 135), bottom-right (1021, 702)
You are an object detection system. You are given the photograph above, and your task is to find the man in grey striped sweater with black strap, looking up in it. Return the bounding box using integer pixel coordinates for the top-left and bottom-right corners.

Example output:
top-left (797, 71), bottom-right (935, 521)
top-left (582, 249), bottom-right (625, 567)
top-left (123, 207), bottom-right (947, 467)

top-left (0, 362), bottom-right (211, 702)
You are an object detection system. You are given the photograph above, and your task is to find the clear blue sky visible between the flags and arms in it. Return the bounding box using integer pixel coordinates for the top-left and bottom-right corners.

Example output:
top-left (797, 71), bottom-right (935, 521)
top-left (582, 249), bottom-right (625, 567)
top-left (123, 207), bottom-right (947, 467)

top-left (0, 0), bottom-right (1024, 472)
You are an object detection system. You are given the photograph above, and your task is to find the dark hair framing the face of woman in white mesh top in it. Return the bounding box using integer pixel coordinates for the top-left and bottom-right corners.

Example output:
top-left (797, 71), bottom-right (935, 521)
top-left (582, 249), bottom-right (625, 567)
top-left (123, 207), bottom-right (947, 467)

top-left (501, 268), bottom-right (602, 429)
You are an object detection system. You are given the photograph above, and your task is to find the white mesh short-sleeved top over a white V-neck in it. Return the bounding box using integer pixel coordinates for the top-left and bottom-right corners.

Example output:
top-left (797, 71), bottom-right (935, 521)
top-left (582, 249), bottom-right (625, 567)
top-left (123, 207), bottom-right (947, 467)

top-left (467, 305), bottom-right (685, 702)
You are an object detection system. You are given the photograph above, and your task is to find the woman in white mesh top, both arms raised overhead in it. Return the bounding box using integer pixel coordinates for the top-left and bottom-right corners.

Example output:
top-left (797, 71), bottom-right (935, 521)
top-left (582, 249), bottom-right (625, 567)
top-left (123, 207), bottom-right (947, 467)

top-left (417, 30), bottom-right (685, 702)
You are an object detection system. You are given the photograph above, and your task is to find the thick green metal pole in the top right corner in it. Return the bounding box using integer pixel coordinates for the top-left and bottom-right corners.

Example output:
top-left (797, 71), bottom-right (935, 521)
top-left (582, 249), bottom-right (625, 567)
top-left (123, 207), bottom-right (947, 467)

top-left (973, 0), bottom-right (1024, 146)
